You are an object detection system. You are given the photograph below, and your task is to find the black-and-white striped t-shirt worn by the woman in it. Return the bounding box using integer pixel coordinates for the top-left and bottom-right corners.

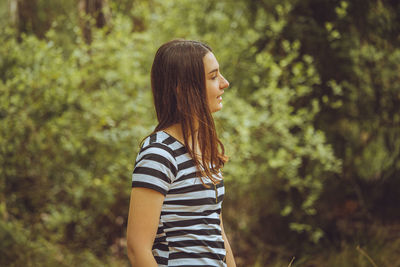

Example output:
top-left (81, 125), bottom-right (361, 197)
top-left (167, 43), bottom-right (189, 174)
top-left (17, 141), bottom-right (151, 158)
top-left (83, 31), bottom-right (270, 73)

top-left (132, 131), bottom-right (226, 267)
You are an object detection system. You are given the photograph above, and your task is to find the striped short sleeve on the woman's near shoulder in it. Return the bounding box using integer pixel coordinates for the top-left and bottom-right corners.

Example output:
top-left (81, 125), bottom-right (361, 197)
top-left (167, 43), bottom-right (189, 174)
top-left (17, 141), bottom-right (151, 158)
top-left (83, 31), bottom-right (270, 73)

top-left (132, 143), bottom-right (177, 196)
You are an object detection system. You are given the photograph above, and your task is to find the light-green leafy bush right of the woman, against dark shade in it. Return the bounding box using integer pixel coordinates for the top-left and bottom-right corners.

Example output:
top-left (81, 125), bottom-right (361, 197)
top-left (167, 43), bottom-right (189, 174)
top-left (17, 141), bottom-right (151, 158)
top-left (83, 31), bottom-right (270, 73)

top-left (218, 39), bottom-right (340, 262)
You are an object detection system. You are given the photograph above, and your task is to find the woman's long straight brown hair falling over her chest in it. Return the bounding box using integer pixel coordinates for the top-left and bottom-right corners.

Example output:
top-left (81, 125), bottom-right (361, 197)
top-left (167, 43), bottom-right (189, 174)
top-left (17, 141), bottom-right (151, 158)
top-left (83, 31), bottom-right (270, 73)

top-left (151, 40), bottom-right (227, 184)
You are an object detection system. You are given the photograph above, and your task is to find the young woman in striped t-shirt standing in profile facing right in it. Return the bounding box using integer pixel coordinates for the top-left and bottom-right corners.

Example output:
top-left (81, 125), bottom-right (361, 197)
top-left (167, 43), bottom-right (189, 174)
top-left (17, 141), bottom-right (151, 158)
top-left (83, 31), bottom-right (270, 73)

top-left (127, 40), bottom-right (236, 267)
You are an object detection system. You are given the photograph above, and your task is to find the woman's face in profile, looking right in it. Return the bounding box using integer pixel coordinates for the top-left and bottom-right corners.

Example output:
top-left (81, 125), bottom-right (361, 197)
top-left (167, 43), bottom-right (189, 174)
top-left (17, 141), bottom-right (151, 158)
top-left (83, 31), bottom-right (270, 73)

top-left (203, 52), bottom-right (229, 112)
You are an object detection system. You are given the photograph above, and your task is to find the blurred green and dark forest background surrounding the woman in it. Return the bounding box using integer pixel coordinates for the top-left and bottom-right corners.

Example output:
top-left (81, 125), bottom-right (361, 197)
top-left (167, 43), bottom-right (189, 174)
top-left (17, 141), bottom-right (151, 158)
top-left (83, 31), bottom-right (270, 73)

top-left (0, 0), bottom-right (400, 267)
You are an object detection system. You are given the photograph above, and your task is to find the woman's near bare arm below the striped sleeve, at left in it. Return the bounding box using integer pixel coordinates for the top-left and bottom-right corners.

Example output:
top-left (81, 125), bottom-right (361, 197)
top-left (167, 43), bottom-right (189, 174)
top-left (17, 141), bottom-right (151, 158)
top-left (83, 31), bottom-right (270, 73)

top-left (127, 187), bottom-right (164, 267)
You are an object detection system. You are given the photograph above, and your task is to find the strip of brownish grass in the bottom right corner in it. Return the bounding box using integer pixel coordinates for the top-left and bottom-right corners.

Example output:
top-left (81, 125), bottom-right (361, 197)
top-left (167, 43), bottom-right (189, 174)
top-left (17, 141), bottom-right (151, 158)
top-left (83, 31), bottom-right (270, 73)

top-left (247, 225), bottom-right (400, 267)
